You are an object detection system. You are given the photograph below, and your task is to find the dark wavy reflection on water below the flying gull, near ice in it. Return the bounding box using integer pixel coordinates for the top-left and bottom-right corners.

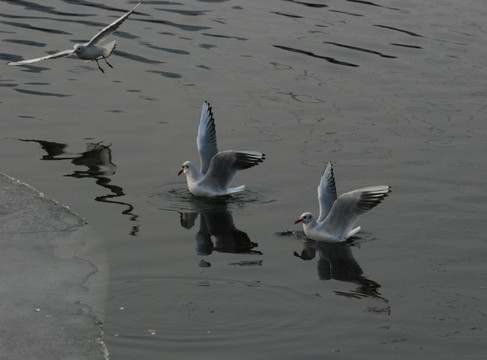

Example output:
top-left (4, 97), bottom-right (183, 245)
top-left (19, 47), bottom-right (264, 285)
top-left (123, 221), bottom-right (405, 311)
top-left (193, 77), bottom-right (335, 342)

top-left (18, 139), bottom-right (139, 236)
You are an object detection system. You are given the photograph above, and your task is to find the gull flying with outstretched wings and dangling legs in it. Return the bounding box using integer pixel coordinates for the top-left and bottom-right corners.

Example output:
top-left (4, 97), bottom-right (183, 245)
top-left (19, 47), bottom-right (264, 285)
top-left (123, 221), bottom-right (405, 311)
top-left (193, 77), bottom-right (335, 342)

top-left (7, 1), bottom-right (142, 73)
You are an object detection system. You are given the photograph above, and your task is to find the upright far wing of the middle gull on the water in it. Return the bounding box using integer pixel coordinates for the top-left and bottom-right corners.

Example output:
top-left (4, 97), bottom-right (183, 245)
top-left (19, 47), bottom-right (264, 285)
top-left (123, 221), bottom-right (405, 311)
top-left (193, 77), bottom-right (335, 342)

top-left (196, 101), bottom-right (218, 174)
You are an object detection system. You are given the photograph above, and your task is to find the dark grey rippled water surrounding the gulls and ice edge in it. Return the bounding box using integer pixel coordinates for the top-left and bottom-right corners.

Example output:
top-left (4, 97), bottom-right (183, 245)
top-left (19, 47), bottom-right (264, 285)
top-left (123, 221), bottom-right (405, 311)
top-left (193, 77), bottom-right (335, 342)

top-left (0, 0), bottom-right (487, 359)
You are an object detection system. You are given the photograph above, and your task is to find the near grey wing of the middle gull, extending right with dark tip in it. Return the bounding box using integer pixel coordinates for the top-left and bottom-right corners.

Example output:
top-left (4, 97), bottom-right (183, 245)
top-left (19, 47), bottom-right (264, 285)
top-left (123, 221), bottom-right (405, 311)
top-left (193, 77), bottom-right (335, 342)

top-left (203, 150), bottom-right (265, 190)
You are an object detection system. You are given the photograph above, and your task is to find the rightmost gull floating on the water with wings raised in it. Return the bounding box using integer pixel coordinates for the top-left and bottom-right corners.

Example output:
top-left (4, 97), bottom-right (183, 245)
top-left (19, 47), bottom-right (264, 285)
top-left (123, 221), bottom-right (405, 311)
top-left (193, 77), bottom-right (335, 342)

top-left (294, 162), bottom-right (391, 242)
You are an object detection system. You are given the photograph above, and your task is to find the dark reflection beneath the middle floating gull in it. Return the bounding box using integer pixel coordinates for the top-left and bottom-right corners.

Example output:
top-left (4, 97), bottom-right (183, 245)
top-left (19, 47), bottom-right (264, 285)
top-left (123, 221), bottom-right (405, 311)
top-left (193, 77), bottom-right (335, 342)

top-left (179, 198), bottom-right (262, 266)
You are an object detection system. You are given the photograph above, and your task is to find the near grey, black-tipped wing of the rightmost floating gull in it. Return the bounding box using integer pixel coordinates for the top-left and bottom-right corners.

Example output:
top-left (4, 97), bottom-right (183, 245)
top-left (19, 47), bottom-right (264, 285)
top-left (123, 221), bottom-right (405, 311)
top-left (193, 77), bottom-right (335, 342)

top-left (320, 185), bottom-right (391, 238)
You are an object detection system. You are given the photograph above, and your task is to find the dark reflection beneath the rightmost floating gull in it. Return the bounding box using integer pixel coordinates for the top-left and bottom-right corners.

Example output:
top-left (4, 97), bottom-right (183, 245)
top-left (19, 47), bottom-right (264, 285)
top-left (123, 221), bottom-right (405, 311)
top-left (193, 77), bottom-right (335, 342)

top-left (294, 239), bottom-right (390, 313)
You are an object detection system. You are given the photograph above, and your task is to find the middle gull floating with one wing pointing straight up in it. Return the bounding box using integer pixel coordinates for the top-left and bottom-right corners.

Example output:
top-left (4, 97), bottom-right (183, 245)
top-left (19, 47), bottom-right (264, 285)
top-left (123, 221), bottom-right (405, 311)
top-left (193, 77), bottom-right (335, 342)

top-left (178, 101), bottom-right (265, 197)
